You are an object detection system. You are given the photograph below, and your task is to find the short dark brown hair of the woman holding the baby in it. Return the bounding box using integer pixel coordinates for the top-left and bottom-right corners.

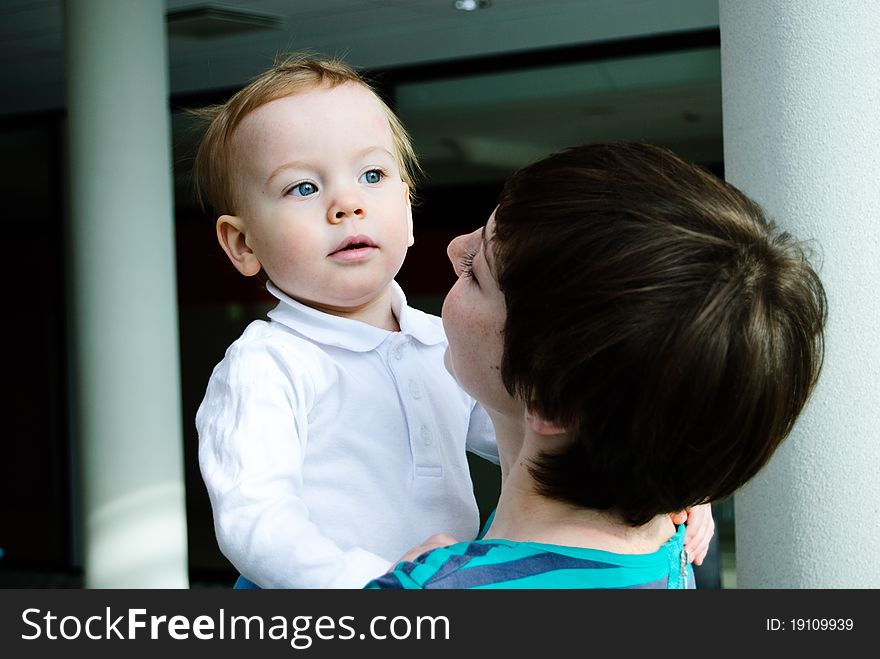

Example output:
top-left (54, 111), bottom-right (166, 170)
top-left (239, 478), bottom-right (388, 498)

top-left (491, 144), bottom-right (826, 525)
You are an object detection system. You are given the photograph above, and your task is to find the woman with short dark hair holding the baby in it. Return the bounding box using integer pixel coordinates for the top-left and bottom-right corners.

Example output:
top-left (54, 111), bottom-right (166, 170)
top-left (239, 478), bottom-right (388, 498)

top-left (369, 144), bottom-right (826, 588)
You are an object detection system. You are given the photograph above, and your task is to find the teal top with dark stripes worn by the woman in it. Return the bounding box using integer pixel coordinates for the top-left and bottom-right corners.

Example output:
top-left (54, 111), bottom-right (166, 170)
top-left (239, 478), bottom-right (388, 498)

top-left (366, 524), bottom-right (694, 589)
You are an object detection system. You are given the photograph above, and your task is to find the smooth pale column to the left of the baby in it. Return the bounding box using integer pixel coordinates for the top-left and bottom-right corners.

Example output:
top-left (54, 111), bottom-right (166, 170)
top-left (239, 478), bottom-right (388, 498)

top-left (64, 0), bottom-right (188, 588)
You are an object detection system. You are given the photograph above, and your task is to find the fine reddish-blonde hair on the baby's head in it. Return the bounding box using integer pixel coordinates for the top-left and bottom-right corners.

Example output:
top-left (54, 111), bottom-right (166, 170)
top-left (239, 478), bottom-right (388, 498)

top-left (192, 53), bottom-right (419, 216)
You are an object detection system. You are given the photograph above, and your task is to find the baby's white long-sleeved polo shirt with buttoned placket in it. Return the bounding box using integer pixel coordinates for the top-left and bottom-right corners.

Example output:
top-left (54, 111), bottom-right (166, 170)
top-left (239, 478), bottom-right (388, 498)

top-left (196, 283), bottom-right (498, 588)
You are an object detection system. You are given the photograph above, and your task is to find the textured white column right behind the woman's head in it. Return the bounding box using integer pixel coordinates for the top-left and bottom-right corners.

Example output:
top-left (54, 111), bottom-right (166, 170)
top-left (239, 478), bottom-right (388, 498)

top-left (720, 0), bottom-right (880, 588)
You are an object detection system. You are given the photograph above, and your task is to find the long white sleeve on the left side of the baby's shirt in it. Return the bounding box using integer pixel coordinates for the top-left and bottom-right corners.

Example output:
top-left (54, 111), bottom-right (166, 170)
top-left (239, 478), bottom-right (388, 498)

top-left (196, 339), bottom-right (391, 588)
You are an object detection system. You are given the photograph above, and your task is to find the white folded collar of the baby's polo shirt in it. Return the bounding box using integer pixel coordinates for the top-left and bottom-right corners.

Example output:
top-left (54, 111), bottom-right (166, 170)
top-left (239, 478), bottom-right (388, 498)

top-left (266, 280), bottom-right (446, 352)
